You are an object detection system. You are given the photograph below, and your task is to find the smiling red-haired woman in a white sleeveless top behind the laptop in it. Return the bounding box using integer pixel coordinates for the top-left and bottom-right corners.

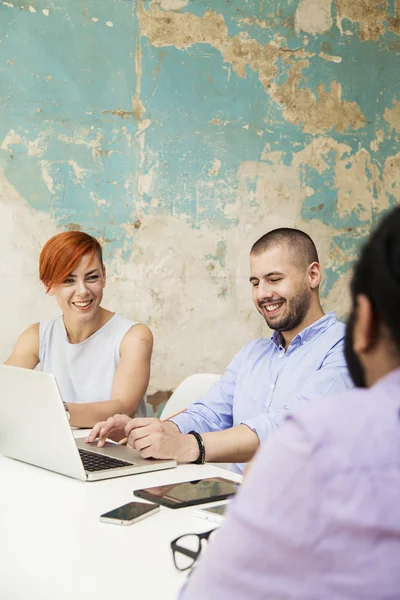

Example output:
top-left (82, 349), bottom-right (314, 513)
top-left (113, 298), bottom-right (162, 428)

top-left (6, 231), bottom-right (153, 427)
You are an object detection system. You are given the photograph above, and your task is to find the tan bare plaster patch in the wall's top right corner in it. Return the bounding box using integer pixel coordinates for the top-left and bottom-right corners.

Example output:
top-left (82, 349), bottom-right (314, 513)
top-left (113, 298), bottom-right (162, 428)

top-left (336, 0), bottom-right (400, 40)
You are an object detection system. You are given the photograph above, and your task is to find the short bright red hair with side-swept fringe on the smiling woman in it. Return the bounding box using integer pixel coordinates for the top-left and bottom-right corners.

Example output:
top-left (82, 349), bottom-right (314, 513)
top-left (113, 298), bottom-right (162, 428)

top-left (39, 231), bottom-right (103, 288)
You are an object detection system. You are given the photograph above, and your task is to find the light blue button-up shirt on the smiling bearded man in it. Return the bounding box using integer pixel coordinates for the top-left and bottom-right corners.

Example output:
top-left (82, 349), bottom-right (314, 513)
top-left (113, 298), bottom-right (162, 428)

top-left (172, 312), bottom-right (353, 472)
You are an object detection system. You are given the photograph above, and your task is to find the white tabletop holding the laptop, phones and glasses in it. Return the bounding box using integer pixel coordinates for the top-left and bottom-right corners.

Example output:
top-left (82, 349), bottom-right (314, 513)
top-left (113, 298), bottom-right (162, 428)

top-left (0, 433), bottom-right (241, 600)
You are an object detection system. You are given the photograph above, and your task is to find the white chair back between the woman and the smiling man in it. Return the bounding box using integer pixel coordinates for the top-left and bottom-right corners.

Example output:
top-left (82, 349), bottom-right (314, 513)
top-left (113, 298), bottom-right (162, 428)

top-left (160, 373), bottom-right (221, 419)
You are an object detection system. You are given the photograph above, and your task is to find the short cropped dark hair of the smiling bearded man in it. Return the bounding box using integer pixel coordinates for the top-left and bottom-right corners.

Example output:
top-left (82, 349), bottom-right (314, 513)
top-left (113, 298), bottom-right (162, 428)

top-left (251, 227), bottom-right (319, 267)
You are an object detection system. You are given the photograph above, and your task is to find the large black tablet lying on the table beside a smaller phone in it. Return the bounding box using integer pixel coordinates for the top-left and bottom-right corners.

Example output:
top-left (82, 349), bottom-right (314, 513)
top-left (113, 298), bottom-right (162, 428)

top-left (133, 477), bottom-right (240, 508)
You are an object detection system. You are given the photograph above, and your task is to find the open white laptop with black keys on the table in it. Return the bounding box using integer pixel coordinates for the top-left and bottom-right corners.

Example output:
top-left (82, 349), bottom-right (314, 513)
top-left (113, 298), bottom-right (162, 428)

top-left (0, 365), bottom-right (176, 481)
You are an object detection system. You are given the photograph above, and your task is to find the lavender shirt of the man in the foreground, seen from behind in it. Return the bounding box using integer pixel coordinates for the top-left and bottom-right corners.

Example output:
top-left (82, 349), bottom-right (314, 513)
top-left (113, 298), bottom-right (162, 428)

top-left (181, 369), bottom-right (400, 600)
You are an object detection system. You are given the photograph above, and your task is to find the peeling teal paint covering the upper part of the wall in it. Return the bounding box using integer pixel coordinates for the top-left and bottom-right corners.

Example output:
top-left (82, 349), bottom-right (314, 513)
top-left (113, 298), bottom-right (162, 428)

top-left (0, 0), bottom-right (400, 296)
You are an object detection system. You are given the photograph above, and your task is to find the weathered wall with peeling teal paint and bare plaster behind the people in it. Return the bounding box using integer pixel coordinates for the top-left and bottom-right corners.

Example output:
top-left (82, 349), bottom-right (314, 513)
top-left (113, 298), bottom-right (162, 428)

top-left (0, 0), bottom-right (400, 408)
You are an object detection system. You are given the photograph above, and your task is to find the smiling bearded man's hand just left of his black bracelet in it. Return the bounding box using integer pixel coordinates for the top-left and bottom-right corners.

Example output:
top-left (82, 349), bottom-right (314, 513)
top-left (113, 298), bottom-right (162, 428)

top-left (125, 418), bottom-right (199, 462)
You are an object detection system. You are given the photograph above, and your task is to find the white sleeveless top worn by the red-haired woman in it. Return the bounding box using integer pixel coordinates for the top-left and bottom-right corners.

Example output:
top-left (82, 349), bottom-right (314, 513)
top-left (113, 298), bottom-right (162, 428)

top-left (39, 315), bottom-right (146, 417)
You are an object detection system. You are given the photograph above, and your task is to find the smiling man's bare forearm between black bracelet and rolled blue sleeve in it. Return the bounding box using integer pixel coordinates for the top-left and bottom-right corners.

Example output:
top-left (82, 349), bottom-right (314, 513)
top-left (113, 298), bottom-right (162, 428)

top-left (200, 425), bottom-right (260, 462)
